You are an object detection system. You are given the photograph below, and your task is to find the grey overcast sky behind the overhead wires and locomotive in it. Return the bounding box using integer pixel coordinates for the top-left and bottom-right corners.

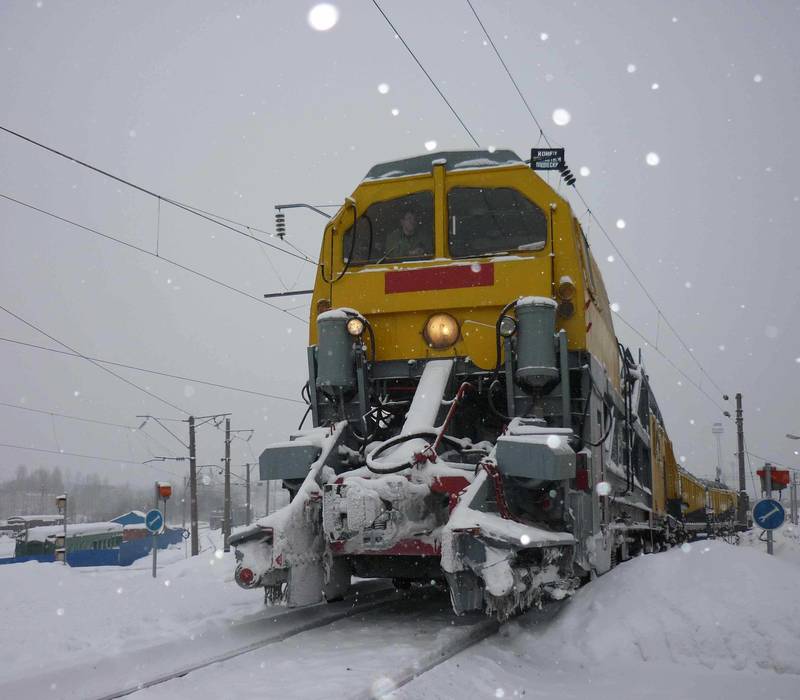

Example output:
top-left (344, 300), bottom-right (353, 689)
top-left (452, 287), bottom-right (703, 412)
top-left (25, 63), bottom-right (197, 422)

top-left (0, 0), bottom-right (800, 492)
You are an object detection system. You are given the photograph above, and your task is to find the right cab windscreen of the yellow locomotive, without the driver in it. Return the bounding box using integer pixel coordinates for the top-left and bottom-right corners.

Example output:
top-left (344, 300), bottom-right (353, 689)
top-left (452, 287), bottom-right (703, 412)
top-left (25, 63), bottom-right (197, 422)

top-left (447, 187), bottom-right (547, 258)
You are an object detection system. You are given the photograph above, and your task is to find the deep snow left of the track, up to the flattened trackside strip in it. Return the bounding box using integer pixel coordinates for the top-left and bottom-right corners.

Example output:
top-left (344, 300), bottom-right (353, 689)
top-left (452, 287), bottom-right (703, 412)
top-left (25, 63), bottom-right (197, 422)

top-left (0, 532), bottom-right (263, 684)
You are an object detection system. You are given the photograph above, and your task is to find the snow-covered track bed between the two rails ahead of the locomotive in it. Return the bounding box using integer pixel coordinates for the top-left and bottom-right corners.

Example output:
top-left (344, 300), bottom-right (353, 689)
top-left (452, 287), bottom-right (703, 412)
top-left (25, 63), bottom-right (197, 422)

top-left (119, 590), bottom-right (564, 700)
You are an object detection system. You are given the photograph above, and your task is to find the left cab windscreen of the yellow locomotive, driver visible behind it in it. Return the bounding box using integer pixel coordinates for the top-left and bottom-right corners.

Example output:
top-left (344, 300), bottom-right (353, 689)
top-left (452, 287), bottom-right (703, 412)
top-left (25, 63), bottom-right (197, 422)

top-left (342, 192), bottom-right (433, 265)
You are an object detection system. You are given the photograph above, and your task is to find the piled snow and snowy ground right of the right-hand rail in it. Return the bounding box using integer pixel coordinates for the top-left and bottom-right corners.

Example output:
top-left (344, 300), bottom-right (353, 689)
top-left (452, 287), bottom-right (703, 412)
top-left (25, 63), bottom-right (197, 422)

top-left (393, 528), bottom-right (800, 700)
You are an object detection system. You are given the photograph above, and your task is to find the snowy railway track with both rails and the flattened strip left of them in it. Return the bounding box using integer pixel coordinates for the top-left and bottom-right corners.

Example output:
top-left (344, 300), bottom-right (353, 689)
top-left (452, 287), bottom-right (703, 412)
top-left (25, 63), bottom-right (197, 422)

top-left (0, 582), bottom-right (568, 700)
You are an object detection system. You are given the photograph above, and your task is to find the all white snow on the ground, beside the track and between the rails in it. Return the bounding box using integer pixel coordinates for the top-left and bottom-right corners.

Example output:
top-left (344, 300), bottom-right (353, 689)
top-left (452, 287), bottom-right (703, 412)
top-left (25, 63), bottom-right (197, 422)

top-left (0, 527), bottom-right (800, 700)
